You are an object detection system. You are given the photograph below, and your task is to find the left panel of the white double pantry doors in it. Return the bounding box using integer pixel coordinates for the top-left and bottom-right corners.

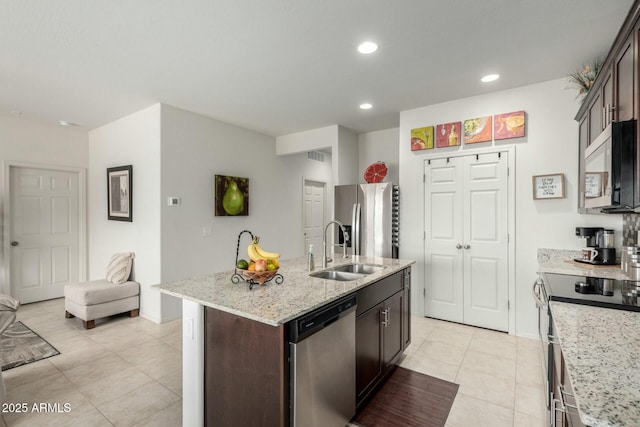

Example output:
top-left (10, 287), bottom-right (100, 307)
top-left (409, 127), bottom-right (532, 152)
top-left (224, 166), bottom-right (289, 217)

top-left (424, 157), bottom-right (464, 322)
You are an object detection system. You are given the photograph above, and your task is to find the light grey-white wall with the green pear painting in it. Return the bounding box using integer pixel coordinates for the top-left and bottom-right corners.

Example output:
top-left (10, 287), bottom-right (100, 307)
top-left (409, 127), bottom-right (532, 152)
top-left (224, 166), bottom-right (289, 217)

top-left (161, 105), bottom-right (332, 281)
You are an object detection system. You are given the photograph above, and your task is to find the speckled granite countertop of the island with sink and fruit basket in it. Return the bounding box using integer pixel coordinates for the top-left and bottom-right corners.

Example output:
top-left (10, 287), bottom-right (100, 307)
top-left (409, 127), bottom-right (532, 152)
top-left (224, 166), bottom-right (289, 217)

top-left (153, 256), bottom-right (415, 326)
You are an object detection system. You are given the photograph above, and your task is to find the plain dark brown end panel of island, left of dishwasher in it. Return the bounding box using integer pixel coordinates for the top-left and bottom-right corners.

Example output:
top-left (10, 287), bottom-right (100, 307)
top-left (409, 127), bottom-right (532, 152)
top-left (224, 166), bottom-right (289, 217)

top-left (204, 307), bottom-right (289, 427)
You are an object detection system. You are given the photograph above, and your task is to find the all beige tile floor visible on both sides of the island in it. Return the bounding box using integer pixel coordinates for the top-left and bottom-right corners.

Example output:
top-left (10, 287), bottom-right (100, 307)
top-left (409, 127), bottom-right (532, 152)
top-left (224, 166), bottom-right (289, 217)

top-left (0, 299), bottom-right (544, 427)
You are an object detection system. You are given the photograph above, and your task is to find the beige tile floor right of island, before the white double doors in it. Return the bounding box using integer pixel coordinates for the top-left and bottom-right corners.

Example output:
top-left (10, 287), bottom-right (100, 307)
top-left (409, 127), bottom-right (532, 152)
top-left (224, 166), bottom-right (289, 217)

top-left (400, 316), bottom-right (545, 427)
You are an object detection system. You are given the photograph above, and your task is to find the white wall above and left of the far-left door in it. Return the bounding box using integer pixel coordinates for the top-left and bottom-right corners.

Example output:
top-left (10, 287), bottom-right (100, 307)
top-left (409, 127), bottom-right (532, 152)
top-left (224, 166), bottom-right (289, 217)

top-left (0, 114), bottom-right (89, 293)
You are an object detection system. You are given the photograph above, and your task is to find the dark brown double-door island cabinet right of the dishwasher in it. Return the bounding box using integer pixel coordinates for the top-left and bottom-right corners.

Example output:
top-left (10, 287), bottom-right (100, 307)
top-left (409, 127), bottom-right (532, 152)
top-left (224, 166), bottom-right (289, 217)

top-left (356, 268), bottom-right (411, 408)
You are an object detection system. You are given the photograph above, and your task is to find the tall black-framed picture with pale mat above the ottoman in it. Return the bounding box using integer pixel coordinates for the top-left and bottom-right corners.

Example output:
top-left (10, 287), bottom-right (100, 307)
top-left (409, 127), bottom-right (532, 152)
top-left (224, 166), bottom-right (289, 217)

top-left (107, 165), bottom-right (133, 222)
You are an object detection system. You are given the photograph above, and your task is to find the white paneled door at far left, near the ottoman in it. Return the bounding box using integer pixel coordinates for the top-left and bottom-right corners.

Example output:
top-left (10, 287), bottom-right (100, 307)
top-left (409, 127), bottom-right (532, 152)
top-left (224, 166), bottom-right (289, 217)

top-left (9, 166), bottom-right (80, 303)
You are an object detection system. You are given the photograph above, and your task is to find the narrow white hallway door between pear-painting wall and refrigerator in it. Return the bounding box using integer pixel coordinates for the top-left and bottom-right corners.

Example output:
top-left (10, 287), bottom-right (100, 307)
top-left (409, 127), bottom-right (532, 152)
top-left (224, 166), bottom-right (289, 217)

top-left (302, 179), bottom-right (325, 259)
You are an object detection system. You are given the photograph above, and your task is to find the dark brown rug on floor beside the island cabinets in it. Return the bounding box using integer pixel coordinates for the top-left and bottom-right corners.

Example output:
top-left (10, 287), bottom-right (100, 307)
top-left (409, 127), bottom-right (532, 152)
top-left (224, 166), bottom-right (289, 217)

top-left (351, 367), bottom-right (459, 427)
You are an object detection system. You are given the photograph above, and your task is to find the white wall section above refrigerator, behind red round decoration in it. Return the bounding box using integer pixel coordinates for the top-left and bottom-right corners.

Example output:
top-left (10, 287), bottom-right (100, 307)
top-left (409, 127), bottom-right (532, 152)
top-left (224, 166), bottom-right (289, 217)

top-left (358, 128), bottom-right (400, 184)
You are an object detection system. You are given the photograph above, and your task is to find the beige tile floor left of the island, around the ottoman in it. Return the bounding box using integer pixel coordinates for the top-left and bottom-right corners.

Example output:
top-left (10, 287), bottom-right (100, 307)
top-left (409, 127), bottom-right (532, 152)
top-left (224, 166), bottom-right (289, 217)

top-left (0, 299), bottom-right (182, 427)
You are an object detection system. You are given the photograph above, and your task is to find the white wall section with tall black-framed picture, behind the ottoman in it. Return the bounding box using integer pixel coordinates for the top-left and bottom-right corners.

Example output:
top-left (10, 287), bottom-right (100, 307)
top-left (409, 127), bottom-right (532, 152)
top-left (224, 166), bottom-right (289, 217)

top-left (88, 104), bottom-right (162, 323)
